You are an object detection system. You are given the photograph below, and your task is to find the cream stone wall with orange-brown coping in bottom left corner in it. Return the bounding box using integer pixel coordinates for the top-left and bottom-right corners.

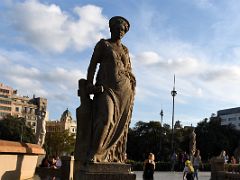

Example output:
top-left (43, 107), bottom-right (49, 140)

top-left (0, 140), bottom-right (45, 180)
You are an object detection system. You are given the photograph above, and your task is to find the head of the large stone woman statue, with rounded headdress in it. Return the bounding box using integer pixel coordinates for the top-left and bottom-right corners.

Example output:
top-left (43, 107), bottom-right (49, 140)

top-left (109, 16), bottom-right (130, 39)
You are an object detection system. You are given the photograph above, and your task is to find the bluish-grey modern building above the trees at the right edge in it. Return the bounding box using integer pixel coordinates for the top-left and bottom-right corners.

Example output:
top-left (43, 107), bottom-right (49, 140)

top-left (217, 107), bottom-right (240, 130)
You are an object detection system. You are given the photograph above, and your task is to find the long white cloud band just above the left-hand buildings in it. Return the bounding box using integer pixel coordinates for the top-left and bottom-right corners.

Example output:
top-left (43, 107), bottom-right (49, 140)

top-left (0, 51), bottom-right (84, 98)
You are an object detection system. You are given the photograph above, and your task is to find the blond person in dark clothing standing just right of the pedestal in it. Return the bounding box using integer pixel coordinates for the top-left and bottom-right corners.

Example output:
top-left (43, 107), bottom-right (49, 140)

top-left (143, 153), bottom-right (155, 180)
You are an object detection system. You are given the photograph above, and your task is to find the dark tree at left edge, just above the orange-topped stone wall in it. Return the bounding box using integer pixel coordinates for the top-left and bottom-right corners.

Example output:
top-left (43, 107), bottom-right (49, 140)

top-left (0, 116), bottom-right (35, 143)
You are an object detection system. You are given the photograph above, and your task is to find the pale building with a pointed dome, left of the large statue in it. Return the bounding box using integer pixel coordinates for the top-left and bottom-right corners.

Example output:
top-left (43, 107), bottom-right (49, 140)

top-left (46, 109), bottom-right (77, 135)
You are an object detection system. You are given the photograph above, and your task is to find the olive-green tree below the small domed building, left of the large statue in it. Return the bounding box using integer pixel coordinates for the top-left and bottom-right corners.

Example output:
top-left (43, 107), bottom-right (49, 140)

top-left (44, 130), bottom-right (75, 156)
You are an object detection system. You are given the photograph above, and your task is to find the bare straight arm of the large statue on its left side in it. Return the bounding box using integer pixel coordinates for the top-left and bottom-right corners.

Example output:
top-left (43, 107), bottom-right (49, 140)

top-left (87, 41), bottom-right (101, 85)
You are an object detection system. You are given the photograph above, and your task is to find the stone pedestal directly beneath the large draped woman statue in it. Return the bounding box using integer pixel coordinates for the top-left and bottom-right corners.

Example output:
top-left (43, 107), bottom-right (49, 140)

top-left (74, 161), bottom-right (136, 180)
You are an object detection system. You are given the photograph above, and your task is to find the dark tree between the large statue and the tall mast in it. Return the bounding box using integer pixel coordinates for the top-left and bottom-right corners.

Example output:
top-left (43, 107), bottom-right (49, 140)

top-left (127, 121), bottom-right (174, 161)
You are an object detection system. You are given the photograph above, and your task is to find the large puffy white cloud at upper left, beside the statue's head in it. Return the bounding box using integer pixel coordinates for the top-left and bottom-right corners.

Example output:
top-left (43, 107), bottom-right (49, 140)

top-left (7, 0), bottom-right (107, 53)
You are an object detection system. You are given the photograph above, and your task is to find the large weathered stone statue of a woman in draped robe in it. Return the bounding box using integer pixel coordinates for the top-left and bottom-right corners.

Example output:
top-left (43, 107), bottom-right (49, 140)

top-left (87, 16), bottom-right (136, 162)
